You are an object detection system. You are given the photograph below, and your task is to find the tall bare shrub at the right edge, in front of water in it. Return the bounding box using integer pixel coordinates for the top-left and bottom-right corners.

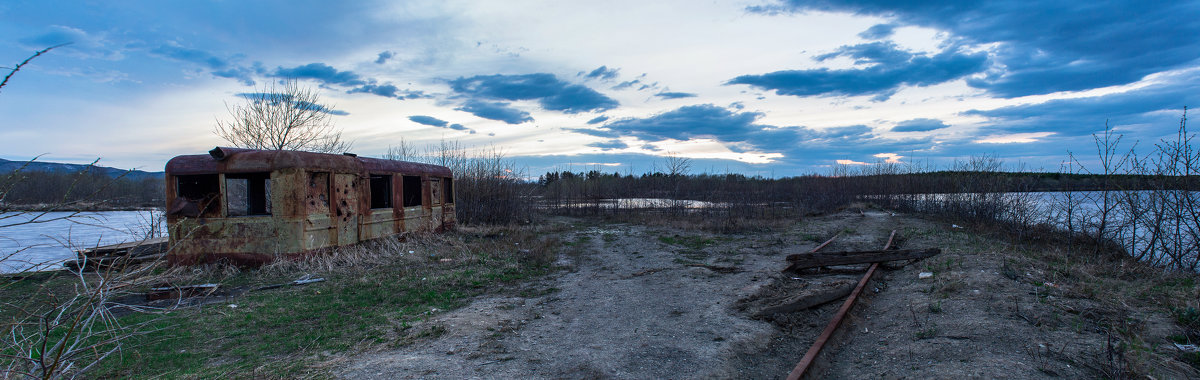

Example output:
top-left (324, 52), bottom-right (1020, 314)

top-left (1051, 109), bottom-right (1200, 272)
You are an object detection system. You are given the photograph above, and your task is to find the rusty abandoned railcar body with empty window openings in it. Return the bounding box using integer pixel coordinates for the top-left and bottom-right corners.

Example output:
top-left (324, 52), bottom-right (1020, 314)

top-left (166, 147), bottom-right (455, 264)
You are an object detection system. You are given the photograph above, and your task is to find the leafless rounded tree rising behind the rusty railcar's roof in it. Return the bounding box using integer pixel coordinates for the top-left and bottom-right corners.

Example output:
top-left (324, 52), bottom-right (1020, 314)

top-left (214, 79), bottom-right (350, 153)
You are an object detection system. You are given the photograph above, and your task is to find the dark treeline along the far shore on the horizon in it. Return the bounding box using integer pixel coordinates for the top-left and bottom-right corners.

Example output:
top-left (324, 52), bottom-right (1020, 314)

top-left (0, 154), bottom-right (1200, 210)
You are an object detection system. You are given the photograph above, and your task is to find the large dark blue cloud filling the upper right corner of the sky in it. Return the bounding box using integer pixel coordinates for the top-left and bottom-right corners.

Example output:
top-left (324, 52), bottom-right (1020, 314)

top-left (748, 0), bottom-right (1200, 97)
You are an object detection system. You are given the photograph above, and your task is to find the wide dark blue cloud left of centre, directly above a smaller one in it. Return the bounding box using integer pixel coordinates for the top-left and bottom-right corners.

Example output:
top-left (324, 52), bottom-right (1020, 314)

top-left (450, 73), bottom-right (619, 114)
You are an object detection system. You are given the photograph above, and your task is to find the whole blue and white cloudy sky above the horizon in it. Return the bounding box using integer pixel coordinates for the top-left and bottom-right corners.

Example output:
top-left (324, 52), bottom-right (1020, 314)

top-left (0, 0), bottom-right (1200, 177)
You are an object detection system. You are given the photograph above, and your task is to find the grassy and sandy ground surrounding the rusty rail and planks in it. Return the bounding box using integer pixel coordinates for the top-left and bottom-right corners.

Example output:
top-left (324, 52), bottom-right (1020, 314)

top-left (4, 209), bottom-right (1200, 379)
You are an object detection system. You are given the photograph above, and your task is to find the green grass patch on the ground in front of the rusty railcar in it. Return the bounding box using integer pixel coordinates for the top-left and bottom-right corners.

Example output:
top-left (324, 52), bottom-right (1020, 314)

top-left (0, 226), bottom-right (562, 379)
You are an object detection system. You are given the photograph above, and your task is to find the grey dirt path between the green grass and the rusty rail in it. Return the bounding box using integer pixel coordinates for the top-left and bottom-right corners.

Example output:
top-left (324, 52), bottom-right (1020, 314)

top-left (343, 216), bottom-right (785, 379)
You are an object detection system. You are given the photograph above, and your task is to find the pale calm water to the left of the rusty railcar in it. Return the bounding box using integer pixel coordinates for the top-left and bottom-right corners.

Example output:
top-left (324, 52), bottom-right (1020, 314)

top-left (0, 210), bottom-right (164, 273)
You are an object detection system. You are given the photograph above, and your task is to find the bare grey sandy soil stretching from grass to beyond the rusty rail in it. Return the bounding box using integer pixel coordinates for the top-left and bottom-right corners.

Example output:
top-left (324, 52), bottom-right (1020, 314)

top-left (336, 211), bottom-right (1196, 379)
